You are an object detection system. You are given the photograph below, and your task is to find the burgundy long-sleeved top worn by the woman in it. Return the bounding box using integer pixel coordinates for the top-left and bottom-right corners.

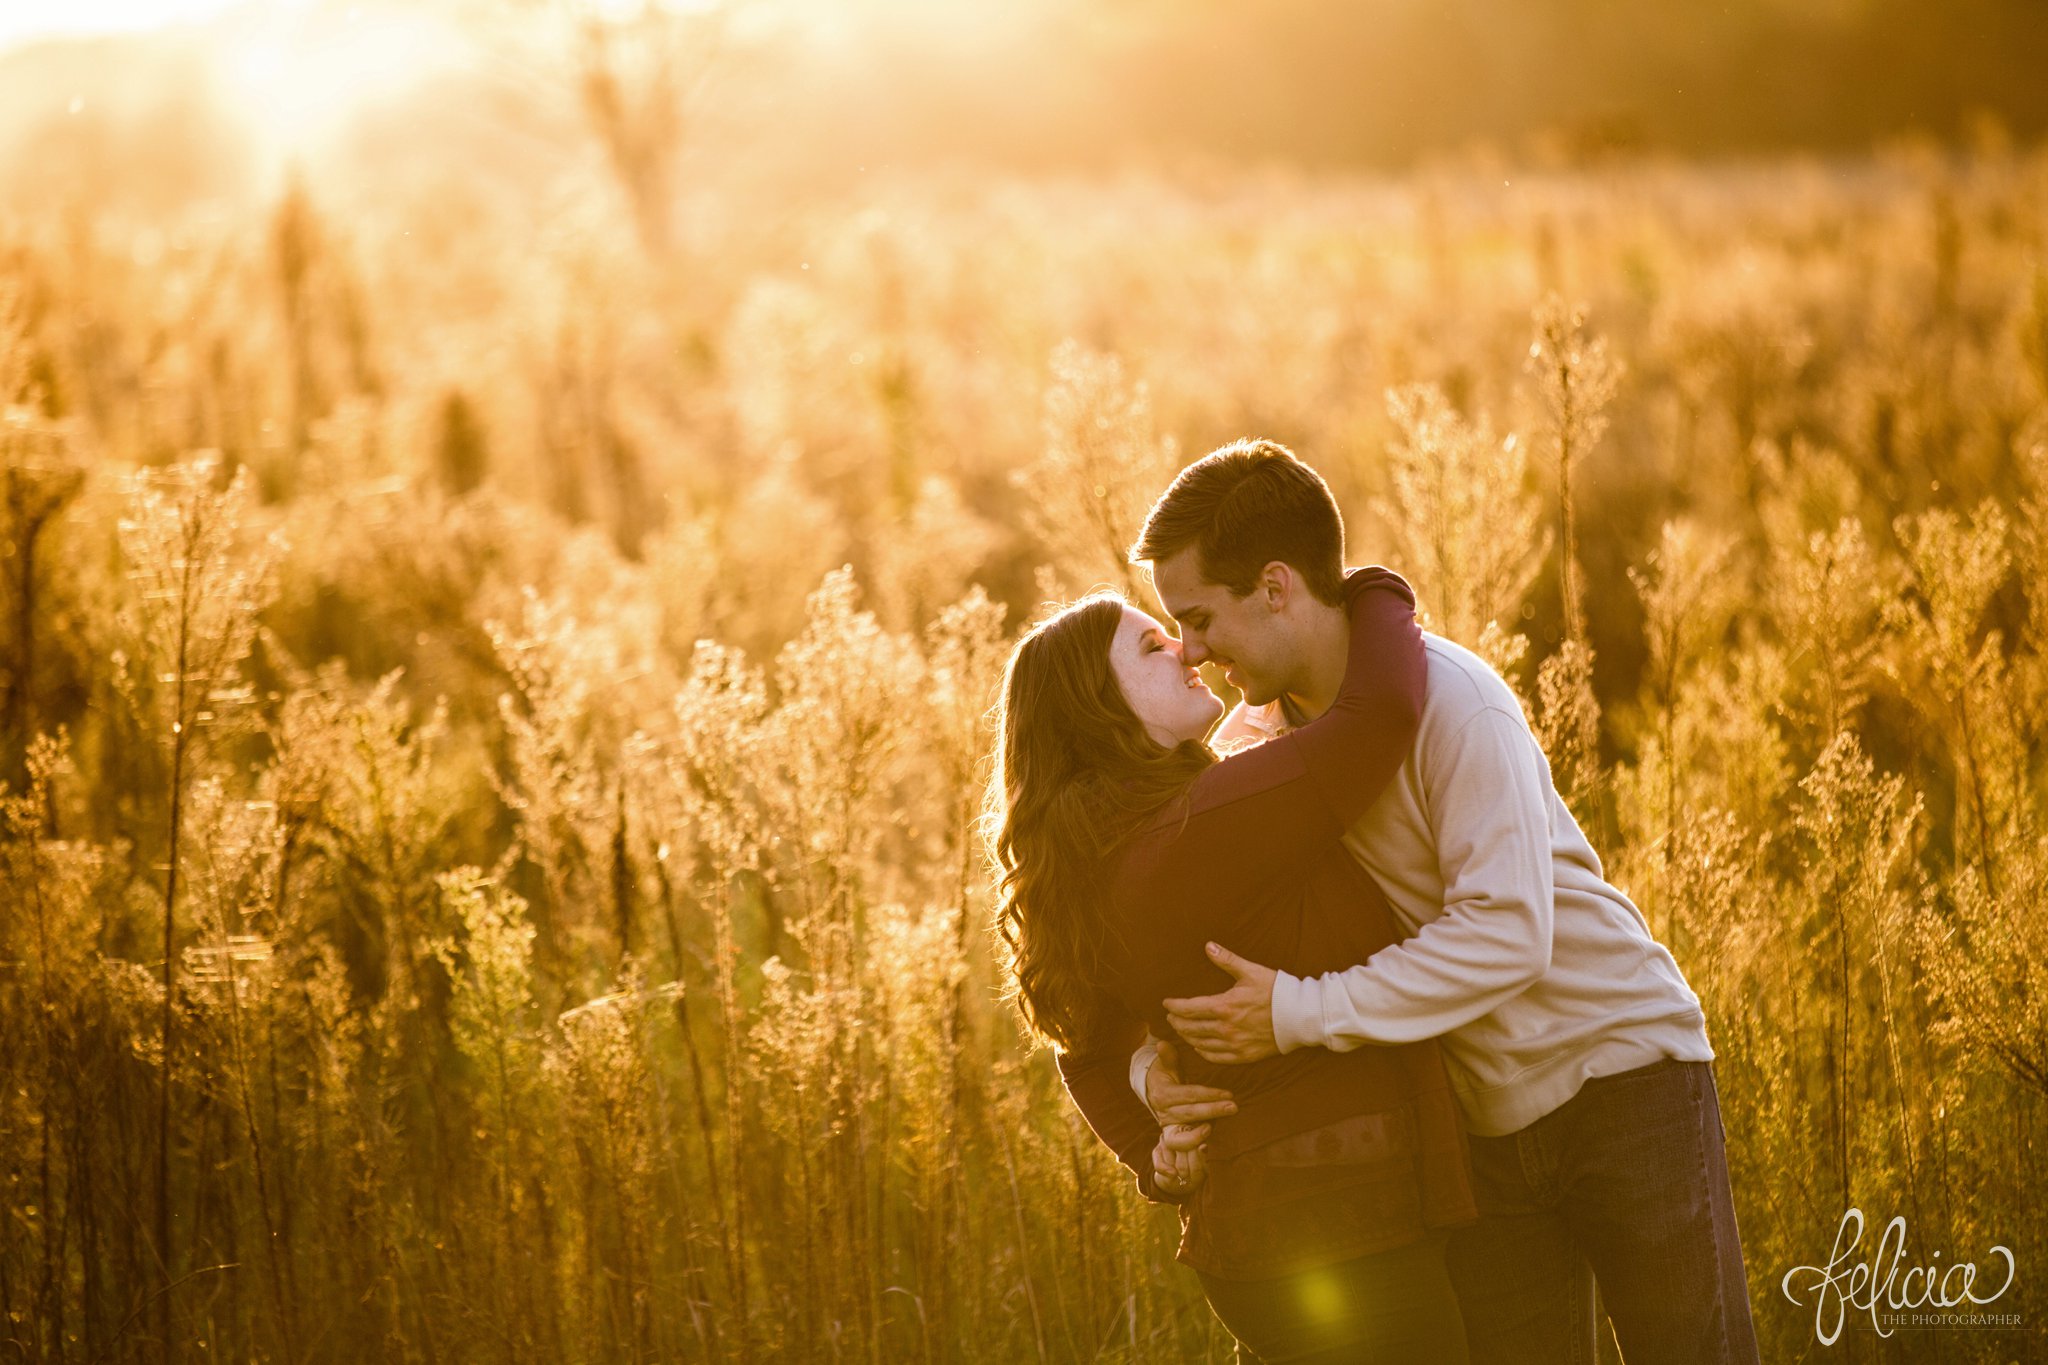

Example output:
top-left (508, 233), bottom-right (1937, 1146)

top-left (1059, 567), bottom-right (1477, 1279)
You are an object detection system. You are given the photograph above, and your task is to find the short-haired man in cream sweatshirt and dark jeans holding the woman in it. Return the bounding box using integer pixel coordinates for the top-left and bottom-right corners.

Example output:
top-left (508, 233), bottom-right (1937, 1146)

top-left (1130, 442), bottom-right (1757, 1365)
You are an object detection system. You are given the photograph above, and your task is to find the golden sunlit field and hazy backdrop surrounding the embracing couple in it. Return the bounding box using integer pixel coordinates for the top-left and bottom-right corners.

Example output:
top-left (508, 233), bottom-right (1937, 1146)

top-left (0, 0), bottom-right (2048, 1361)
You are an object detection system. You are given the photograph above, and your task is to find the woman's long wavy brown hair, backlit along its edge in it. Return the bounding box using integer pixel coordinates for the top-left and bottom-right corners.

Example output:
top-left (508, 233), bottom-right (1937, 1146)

top-left (983, 591), bottom-right (1217, 1050)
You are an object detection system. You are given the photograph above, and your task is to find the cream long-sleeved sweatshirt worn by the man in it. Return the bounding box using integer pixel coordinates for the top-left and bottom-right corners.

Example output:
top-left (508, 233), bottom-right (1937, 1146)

top-left (1130, 632), bottom-right (1714, 1136)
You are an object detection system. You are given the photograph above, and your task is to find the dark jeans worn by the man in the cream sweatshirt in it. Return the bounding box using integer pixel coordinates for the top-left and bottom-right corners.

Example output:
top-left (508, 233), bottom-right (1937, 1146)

top-left (1448, 1058), bottom-right (1757, 1365)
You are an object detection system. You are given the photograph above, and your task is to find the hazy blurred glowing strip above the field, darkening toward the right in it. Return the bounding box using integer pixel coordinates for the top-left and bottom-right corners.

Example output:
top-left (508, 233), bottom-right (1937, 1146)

top-left (0, 0), bottom-right (2048, 209)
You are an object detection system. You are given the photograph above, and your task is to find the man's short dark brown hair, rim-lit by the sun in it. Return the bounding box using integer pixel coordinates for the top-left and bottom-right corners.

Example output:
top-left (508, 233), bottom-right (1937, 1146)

top-left (1130, 440), bottom-right (1343, 606)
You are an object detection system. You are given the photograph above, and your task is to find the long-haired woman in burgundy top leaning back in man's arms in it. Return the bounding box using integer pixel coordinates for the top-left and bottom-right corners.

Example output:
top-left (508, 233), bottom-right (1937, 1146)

top-left (991, 569), bottom-right (1477, 1365)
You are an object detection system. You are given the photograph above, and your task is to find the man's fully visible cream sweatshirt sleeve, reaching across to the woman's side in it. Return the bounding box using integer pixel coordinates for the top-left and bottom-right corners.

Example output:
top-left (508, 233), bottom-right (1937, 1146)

top-left (1274, 706), bottom-right (1554, 1052)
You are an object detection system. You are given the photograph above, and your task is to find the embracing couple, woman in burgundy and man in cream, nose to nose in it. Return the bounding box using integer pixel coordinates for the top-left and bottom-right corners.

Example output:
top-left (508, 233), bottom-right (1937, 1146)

top-left (991, 442), bottom-right (1757, 1365)
